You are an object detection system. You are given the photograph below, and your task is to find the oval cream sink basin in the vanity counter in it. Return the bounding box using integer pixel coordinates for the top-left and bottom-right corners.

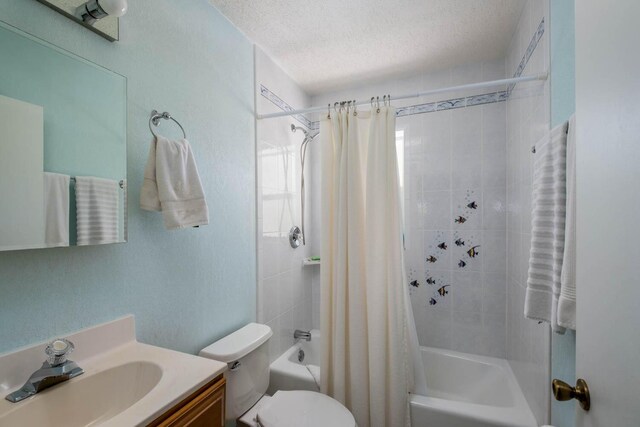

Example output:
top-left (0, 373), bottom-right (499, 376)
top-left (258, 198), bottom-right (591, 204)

top-left (0, 361), bottom-right (162, 427)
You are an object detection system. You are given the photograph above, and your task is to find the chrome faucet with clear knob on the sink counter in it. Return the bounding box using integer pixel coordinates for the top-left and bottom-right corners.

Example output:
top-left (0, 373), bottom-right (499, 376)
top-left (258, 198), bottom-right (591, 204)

top-left (5, 339), bottom-right (84, 403)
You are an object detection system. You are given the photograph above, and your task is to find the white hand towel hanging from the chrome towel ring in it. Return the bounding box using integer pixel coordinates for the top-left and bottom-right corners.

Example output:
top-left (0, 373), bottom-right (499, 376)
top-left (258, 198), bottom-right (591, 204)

top-left (140, 137), bottom-right (209, 230)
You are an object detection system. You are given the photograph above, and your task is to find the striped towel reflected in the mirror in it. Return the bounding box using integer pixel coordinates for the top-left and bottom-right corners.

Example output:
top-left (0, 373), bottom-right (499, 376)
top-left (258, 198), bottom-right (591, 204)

top-left (76, 176), bottom-right (120, 246)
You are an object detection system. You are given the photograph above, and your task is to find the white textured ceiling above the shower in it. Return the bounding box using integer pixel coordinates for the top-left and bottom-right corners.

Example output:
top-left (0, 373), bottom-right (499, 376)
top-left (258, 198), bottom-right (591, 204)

top-left (210, 0), bottom-right (524, 95)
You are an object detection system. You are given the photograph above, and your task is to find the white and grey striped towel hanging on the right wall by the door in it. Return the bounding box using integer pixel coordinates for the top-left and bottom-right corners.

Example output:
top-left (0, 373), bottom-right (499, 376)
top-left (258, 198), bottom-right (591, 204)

top-left (524, 123), bottom-right (567, 333)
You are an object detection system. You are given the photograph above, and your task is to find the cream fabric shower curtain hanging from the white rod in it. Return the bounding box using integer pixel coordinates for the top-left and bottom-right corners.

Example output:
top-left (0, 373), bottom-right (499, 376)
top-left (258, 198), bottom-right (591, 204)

top-left (320, 107), bottom-right (426, 427)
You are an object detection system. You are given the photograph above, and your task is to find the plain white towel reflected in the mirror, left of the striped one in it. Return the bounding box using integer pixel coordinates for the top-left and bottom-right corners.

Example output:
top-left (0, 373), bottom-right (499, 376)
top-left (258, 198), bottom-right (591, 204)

top-left (44, 172), bottom-right (71, 248)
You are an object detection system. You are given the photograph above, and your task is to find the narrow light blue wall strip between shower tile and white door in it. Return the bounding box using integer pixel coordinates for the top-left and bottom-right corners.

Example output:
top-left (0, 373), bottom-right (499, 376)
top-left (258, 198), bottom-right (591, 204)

top-left (550, 0), bottom-right (576, 427)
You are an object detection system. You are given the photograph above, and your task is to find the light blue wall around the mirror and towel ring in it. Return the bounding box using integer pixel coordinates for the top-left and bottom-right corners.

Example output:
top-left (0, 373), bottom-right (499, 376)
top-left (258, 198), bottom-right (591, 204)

top-left (0, 0), bottom-right (256, 353)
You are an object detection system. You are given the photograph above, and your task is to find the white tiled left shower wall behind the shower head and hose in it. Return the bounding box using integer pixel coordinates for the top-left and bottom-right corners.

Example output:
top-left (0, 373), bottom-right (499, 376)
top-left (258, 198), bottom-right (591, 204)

top-left (256, 47), bottom-right (317, 361)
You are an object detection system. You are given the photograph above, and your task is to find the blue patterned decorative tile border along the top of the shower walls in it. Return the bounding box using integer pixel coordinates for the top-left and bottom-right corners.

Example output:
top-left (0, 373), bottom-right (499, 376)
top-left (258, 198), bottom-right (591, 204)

top-left (260, 18), bottom-right (545, 130)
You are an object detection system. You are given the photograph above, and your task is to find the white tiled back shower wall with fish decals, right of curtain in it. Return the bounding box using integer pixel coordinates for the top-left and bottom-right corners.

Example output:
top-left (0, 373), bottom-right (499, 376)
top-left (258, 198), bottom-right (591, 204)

top-left (398, 96), bottom-right (506, 357)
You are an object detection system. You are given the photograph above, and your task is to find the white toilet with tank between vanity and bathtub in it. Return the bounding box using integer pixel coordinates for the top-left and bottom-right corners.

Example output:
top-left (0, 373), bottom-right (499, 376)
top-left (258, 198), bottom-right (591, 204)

top-left (200, 323), bottom-right (356, 427)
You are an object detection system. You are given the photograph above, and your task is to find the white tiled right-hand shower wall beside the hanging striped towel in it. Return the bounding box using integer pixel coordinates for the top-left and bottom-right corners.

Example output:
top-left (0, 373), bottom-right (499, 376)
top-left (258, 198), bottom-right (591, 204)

top-left (505, 0), bottom-right (550, 424)
